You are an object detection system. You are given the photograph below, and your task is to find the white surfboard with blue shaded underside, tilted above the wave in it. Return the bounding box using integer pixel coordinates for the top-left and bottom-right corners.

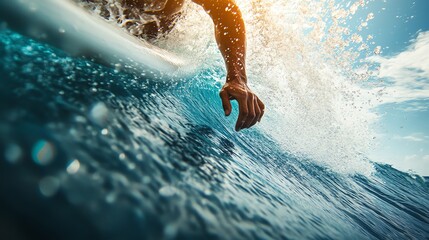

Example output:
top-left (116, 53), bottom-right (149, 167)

top-left (0, 0), bottom-right (187, 75)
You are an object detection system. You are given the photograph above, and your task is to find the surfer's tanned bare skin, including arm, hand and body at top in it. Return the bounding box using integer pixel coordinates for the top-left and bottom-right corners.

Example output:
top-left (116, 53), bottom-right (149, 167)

top-left (125, 0), bottom-right (265, 131)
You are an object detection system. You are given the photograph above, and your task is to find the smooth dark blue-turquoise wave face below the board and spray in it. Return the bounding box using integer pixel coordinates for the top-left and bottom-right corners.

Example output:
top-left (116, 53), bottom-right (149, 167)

top-left (0, 30), bottom-right (429, 239)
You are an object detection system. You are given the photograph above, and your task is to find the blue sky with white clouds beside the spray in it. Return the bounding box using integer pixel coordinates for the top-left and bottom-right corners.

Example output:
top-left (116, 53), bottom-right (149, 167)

top-left (351, 0), bottom-right (429, 176)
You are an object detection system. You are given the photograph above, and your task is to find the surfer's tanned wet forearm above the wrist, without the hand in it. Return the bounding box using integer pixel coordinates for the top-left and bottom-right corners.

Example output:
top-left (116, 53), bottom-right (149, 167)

top-left (194, 0), bottom-right (247, 83)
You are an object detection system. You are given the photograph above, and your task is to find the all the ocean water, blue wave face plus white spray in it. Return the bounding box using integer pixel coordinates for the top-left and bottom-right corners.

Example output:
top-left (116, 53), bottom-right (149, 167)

top-left (0, 1), bottom-right (429, 239)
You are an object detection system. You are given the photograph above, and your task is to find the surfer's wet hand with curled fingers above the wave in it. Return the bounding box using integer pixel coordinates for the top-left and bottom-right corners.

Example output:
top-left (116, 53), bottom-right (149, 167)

top-left (219, 81), bottom-right (265, 131)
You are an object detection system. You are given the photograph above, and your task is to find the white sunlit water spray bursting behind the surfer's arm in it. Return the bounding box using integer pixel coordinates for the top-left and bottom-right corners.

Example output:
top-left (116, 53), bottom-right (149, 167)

top-left (78, 0), bottom-right (380, 174)
